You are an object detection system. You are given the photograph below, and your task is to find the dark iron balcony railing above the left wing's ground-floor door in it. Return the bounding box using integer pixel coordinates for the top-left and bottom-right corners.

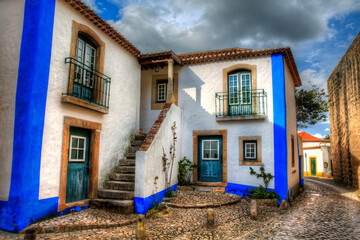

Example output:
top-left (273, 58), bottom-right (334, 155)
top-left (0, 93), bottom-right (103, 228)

top-left (63, 57), bottom-right (111, 108)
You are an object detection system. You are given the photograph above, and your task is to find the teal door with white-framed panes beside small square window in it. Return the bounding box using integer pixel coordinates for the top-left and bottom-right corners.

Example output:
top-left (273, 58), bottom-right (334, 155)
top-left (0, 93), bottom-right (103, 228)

top-left (198, 136), bottom-right (222, 182)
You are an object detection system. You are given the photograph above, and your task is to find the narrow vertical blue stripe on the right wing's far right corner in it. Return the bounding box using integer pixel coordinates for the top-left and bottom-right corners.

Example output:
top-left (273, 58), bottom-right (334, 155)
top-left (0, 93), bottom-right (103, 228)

top-left (271, 53), bottom-right (288, 200)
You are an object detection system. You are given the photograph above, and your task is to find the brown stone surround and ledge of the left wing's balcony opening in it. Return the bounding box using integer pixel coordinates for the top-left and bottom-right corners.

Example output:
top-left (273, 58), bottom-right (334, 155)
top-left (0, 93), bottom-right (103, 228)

top-left (61, 20), bottom-right (109, 114)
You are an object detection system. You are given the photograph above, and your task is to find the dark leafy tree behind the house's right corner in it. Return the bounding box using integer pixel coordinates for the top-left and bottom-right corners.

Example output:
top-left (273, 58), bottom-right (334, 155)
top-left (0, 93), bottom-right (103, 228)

top-left (295, 85), bottom-right (329, 128)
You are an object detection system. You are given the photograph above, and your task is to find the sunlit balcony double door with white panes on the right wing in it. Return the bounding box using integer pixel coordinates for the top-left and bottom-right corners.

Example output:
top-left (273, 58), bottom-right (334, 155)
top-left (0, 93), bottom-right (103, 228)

top-left (228, 71), bottom-right (253, 116)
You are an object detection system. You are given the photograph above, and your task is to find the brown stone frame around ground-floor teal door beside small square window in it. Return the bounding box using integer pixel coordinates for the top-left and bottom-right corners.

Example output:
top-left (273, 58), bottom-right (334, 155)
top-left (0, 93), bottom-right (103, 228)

top-left (193, 129), bottom-right (227, 187)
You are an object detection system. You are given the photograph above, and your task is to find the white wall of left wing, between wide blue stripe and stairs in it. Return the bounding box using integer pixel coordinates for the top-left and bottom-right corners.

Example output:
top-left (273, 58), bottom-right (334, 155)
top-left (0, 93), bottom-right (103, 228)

top-left (39, 0), bottom-right (140, 199)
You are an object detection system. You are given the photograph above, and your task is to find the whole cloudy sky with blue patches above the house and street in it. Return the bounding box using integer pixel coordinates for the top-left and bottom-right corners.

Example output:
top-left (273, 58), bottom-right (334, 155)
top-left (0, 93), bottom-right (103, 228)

top-left (83, 0), bottom-right (360, 137)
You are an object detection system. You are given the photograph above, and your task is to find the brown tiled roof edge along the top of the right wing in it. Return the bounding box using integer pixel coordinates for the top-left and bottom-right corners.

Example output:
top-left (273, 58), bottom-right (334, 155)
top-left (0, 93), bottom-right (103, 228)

top-left (139, 47), bottom-right (301, 87)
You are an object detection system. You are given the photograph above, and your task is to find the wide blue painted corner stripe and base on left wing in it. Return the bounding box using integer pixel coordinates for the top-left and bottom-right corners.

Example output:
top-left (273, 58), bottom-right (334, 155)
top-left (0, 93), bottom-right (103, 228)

top-left (0, 0), bottom-right (58, 232)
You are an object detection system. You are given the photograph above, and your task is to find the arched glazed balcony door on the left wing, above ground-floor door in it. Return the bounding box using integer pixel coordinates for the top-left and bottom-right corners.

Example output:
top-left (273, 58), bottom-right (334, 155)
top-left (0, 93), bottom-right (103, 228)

top-left (73, 35), bottom-right (96, 102)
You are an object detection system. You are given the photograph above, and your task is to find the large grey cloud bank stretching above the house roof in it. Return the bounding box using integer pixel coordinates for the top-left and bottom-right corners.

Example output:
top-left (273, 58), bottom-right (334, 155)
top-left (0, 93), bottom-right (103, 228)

top-left (112, 0), bottom-right (360, 53)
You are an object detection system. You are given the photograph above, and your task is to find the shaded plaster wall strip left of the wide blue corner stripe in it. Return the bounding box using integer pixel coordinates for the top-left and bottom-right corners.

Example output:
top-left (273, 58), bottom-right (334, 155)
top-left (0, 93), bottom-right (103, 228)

top-left (0, 0), bottom-right (25, 201)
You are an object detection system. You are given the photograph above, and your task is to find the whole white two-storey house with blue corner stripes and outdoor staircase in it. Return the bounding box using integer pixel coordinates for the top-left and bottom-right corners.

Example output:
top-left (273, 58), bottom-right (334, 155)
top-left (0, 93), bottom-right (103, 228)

top-left (0, 0), bottom-right (301, 231)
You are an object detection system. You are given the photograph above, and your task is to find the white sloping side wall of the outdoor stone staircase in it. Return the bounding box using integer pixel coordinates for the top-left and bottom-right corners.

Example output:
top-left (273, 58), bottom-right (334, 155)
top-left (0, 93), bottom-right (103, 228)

top-left (135, 104), bottom-right (183, 198)
